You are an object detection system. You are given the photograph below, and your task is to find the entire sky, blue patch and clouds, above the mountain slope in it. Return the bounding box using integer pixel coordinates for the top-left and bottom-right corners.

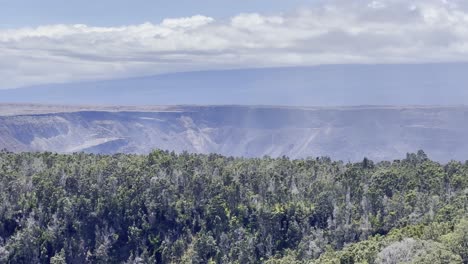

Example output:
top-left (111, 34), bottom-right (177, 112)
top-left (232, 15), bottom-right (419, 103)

top-left (0, 0), bottom-right (468, 89)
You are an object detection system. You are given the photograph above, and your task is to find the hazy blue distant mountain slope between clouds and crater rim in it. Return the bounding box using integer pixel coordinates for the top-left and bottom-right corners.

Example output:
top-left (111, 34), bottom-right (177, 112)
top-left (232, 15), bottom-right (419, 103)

top-left (0, 63), bottom-right (468, 106)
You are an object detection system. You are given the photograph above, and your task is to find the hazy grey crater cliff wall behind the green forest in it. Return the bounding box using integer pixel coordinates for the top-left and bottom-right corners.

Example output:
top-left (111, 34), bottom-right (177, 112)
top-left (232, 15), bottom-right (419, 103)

top-left (0, 105), bottom-right (468, 161)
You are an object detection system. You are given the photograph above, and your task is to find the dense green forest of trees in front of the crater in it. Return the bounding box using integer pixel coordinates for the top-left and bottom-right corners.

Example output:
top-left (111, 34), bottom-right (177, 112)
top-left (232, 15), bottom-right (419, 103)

top-left (0, 151), bottom-right (468, 264)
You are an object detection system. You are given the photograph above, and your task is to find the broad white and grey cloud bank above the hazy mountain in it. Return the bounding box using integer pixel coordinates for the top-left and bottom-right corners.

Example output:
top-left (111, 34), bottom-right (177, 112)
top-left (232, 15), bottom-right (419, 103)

top-left (0, 0), bottom-right (468, 88)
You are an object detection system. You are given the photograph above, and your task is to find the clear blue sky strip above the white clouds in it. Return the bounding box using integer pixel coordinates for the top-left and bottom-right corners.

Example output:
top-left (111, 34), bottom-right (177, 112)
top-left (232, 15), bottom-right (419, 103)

top-left (0, 0), bottom-right (320, 28)
